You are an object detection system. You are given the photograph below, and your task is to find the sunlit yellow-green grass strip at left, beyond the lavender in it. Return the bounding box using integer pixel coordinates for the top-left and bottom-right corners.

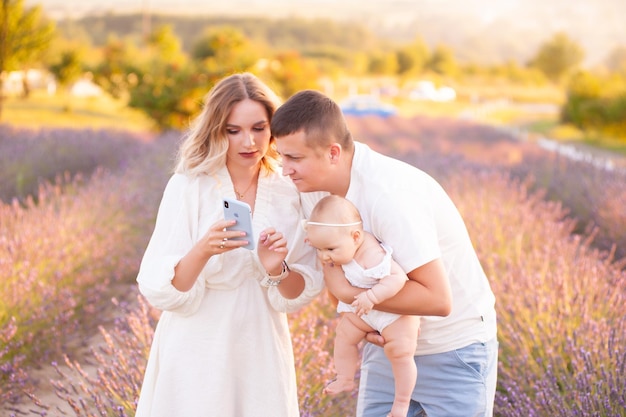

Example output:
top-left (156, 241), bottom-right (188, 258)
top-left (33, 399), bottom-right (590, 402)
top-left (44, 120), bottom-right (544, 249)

top-left (0, 91), bottom-right (153, 131)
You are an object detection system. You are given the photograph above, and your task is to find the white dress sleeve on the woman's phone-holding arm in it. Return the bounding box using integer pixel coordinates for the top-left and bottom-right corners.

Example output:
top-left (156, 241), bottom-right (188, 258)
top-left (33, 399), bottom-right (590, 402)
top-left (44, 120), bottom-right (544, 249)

top-left (137, 174), bottom-right (205, 315)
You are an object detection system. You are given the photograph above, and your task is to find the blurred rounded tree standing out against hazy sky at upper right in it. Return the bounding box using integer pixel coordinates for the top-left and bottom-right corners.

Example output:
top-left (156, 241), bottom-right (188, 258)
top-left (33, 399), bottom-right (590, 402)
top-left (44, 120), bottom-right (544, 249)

top-left (529, 32), bottom-right (585, 82)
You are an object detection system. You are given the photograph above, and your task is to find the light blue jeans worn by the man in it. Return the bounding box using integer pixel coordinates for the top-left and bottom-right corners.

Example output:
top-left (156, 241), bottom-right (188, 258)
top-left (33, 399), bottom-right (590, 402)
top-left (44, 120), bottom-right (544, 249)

top-left (356, 339), bottom-right (498, 417)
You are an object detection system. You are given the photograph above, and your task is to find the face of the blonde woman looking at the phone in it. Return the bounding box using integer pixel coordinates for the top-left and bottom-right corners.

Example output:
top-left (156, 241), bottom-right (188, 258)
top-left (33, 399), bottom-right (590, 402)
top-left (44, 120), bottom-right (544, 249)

top-left (226, 99), bottom-right (271, 168)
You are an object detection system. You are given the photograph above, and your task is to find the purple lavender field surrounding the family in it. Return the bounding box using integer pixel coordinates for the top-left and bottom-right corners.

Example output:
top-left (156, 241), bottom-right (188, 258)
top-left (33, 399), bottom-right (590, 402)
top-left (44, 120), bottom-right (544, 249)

top-left (0, 118), bottom-right (626, 417)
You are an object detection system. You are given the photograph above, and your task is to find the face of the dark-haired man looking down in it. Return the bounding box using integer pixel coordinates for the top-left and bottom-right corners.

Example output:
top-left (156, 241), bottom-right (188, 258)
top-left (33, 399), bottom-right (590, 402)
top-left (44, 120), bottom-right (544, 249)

top-left (276, 131), bottom-right (331, 192)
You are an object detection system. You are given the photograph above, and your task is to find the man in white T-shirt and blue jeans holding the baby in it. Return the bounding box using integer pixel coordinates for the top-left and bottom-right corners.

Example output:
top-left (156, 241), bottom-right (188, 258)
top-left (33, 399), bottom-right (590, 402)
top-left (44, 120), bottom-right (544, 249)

top-left (271, 90), bottom-right (498, 417)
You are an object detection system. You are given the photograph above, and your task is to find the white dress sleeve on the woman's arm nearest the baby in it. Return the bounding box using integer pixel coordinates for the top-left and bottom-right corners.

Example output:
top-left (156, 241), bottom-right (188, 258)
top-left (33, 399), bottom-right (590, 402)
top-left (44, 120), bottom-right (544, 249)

top-left (268, 205), bottom-right (324, 313)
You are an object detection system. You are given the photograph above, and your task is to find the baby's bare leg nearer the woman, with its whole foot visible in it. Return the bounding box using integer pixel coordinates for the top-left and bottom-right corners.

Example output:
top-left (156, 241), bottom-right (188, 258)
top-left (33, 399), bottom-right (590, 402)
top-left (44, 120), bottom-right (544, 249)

top-left (324, 313), bottom-right (373, 395)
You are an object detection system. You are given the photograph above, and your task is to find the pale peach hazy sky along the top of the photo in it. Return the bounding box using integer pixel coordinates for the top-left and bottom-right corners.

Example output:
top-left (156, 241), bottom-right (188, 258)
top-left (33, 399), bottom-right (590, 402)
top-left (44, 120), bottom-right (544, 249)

top-left (26, 0), bottom-right (626, 64)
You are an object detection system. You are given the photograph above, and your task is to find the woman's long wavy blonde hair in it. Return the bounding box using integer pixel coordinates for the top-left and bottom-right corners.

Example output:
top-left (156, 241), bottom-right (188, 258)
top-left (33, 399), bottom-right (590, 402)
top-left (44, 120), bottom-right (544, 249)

top-left (175, 73), bottom-right (279, 176)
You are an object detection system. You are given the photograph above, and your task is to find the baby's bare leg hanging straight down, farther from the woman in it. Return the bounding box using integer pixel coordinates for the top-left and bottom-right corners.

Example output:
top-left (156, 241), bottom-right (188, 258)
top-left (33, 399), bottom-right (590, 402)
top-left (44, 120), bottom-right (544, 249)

top-left (382, 316), bottom-right (420, 417)
